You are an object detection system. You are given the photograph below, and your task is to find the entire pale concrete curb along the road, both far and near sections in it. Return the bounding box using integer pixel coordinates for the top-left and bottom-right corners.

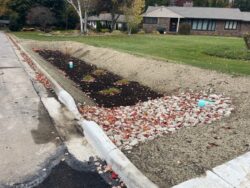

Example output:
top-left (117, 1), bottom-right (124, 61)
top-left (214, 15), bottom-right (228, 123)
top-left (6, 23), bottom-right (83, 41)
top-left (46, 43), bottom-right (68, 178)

top-left (9, 35), bottom-right (158, 188)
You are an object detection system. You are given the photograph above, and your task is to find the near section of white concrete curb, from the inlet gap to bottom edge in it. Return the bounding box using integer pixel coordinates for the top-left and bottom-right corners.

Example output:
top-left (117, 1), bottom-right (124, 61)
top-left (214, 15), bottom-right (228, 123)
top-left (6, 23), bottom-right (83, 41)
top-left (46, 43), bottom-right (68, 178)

top-left (80, 120), bottom-right (157, 188)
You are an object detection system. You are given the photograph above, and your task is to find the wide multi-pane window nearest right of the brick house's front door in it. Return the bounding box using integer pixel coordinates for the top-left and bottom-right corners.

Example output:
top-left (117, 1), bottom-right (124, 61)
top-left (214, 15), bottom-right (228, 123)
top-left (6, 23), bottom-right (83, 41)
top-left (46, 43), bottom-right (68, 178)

top-left (192, 19), bottom-right (216, 31)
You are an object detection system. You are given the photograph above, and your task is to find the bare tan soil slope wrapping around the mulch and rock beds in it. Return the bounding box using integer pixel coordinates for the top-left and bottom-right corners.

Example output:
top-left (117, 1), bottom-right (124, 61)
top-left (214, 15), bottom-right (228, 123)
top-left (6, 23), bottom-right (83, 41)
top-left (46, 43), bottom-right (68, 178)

top-left (19, 41), bottom-right (250, 188)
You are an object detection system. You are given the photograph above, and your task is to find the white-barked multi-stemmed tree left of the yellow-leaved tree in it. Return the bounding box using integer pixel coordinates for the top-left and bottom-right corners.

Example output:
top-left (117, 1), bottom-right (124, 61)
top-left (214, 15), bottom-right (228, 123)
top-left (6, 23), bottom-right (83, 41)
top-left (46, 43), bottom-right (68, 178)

top-left (66, 0), bottom-right (96, 34)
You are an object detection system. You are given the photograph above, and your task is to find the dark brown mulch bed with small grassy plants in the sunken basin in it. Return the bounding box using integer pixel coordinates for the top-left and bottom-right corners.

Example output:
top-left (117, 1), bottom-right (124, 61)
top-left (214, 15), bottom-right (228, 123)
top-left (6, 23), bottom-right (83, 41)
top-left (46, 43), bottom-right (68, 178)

top-left (37, 50), bottom-right (162, 107)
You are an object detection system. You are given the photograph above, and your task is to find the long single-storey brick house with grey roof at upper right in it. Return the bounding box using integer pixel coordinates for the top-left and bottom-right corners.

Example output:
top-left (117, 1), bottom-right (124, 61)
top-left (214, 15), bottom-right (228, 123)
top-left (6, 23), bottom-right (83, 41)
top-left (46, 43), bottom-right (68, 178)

top-left (143, 6), bottom-right (250, 36)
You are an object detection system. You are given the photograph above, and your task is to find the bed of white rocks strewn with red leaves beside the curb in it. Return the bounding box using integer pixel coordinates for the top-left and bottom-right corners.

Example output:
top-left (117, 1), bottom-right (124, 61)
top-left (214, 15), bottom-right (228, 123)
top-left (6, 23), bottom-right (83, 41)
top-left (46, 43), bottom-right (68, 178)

top-left (80, 92), bottom-right (234, 150)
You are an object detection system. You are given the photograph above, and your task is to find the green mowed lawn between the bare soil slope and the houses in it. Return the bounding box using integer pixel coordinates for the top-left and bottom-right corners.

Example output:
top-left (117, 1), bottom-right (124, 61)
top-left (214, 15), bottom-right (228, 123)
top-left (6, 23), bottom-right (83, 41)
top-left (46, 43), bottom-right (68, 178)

top-left (14, 32), bottom-right (250, 75)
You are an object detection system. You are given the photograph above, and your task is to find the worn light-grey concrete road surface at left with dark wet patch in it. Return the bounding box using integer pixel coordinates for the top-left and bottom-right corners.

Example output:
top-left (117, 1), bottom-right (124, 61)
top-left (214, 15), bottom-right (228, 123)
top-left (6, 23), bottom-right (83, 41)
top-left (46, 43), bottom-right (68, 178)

top-left (0, 32), bottom-right (63, 187)
